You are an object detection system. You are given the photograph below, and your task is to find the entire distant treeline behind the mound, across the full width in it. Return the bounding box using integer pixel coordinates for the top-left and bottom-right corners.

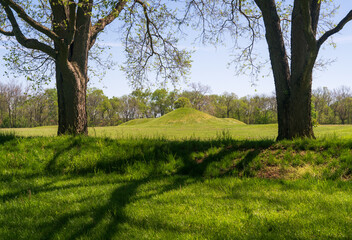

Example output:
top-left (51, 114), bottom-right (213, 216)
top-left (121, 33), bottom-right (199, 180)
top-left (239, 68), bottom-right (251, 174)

top-left (0, 83), bottom-right (352, 128)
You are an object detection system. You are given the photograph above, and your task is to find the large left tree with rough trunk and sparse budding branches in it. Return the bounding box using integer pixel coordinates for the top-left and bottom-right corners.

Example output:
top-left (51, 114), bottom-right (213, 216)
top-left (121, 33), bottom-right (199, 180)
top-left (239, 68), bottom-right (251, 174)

top-left (0, 0), bottom-right (190, 134)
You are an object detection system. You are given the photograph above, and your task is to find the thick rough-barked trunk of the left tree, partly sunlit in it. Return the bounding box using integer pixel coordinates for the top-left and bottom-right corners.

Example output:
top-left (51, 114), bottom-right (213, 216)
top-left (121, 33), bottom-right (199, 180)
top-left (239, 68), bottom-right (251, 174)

top-left (52, 0), bottom-right (92, 135)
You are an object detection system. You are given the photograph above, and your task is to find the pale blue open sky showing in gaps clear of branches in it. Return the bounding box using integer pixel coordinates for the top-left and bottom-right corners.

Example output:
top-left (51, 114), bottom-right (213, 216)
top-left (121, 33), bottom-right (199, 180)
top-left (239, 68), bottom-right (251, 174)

top-left (0, 0), bottom-right (352, 97)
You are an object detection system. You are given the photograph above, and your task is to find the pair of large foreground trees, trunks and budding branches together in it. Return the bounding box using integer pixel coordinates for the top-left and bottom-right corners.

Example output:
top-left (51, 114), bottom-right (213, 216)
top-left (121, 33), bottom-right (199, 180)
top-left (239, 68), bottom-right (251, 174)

top-left (0, 0), bottom-right (352, 140)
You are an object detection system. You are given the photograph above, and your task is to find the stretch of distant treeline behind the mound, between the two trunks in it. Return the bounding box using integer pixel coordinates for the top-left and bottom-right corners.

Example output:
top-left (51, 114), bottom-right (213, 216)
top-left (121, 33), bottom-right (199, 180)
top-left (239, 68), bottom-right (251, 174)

top-left (87, 85), bottom-right (276, 126)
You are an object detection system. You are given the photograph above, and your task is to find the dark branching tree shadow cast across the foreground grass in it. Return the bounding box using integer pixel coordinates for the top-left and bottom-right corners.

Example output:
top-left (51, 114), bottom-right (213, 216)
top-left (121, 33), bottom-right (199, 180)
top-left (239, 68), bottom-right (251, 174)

top-left (2, 138), bottom-right (273, 239)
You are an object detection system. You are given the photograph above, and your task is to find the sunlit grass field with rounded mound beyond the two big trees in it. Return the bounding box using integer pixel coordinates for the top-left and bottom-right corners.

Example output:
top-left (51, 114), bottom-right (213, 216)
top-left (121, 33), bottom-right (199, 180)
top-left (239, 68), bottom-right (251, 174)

top-left (0, 108), bottom-right (352, 140)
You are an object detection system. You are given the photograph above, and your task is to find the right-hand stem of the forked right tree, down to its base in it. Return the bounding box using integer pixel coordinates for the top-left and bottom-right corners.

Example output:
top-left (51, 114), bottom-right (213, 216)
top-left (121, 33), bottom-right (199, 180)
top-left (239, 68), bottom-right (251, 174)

top-left (286, 0), bottom-right (320, 139)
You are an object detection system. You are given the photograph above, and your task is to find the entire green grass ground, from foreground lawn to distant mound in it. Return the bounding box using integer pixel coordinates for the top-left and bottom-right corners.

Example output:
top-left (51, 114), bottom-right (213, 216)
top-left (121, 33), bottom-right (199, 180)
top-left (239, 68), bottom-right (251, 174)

top-left (0, 110), bottom-right (352, 239)
